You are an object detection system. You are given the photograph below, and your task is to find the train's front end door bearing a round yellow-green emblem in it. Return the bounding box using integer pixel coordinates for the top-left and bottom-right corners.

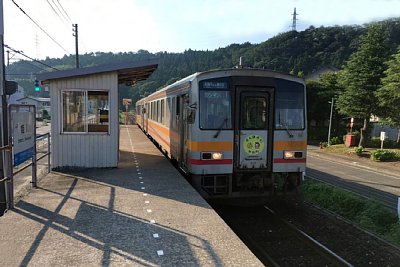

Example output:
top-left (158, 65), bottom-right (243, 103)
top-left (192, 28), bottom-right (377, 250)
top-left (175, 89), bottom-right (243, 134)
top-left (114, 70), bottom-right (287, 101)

top-left (235, 86), bottom-right (272, 170)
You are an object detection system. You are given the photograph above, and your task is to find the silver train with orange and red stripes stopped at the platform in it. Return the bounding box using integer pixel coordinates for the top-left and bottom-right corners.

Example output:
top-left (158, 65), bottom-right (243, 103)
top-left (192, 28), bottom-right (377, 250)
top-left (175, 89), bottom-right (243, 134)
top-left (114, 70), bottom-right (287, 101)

top-left (136, 68), bottom-right (307, 198)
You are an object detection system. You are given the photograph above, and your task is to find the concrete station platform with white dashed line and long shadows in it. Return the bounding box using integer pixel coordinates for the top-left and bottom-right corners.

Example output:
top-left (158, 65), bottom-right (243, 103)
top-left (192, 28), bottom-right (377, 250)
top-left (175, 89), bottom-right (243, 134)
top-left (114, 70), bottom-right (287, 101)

top-left (0, 126), bottom-right (263, 266)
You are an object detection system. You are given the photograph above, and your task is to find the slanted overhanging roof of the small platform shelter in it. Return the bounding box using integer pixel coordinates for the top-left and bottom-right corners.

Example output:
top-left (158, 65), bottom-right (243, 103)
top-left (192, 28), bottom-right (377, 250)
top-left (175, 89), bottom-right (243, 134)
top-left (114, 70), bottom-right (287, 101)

top-left (36, 59), bottom-right (159, 85)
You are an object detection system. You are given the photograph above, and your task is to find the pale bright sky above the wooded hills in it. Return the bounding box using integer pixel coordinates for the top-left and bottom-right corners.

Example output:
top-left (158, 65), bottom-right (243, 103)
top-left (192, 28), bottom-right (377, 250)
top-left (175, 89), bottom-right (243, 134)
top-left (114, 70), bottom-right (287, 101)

top-left (3, 0), bottom-right (400, 62)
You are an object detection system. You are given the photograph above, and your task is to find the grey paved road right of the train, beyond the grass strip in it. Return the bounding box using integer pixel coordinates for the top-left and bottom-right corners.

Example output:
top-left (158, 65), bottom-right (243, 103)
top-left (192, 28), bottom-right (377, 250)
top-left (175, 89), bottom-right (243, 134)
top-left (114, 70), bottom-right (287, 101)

top-left (306, 150), bottom-right (400, 210)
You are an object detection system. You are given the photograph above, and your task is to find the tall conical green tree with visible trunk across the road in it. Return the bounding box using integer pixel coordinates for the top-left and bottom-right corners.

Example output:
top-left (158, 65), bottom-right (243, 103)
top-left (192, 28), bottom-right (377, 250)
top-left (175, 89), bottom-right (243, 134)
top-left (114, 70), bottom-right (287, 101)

top-left (337, 24), bottom-right (389, 147)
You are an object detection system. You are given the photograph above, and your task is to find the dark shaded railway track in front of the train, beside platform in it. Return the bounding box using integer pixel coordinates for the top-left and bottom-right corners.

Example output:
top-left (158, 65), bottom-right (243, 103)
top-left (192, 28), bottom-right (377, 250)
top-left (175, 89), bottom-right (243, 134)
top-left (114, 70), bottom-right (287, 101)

top-left (214, 206), bottom-right (352, 266)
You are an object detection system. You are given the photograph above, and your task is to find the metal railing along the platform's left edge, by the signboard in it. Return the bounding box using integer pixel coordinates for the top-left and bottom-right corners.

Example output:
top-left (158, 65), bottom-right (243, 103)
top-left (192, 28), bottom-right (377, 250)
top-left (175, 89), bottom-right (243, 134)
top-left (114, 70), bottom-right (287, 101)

top-left (0, 133), bottom-right (51, 214)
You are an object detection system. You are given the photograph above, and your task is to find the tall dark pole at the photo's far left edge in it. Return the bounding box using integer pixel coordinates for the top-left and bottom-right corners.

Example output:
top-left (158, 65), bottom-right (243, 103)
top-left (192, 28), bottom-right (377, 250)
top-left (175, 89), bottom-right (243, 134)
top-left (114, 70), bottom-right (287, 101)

top-left (0, 0), bottom-right (10, 216)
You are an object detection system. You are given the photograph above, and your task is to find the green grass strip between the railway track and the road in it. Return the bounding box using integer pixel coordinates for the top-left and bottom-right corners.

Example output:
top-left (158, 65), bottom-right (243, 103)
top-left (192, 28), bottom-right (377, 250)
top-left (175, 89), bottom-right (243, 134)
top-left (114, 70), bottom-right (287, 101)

top-left (302, 180), bottom-right (400, 245)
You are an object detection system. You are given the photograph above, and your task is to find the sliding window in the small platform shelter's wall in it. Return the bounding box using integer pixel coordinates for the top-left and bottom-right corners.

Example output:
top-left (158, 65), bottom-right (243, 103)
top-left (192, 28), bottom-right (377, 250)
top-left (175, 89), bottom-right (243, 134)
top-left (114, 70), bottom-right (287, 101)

top-left (61, 90), bottom-right (110, 133)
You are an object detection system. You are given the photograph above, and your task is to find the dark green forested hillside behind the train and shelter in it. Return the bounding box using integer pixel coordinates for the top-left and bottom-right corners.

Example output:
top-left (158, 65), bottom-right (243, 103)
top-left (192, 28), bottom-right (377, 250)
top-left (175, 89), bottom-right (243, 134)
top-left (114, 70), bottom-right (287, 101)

top-left (6, 18), bottom-right (400, 105)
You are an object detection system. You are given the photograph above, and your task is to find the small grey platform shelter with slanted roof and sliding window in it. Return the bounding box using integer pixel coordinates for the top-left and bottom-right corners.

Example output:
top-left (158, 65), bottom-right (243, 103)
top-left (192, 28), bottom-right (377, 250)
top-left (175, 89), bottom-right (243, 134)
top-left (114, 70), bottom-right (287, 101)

top-left (37, 59), bottom-right (158, 169)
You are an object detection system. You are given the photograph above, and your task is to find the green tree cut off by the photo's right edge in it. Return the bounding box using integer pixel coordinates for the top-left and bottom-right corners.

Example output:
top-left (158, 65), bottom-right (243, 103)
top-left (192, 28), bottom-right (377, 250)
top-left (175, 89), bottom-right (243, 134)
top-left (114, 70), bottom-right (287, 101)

top-left (376, 48), bottom-right (400, 142)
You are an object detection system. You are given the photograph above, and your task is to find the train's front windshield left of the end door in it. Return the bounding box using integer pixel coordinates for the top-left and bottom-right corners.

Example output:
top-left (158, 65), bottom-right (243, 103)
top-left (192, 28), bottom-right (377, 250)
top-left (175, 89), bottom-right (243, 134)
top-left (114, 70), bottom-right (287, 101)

top-left (200, 81), bottom-right (232, 130)
